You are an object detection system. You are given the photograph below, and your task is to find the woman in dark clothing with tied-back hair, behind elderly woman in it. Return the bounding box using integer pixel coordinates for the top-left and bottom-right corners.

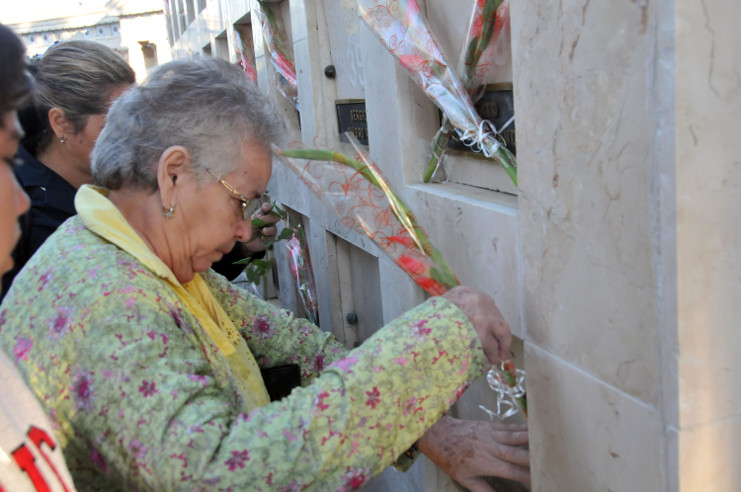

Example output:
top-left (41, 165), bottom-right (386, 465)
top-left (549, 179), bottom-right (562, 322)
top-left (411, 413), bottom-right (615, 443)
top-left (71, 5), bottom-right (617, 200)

top-left (3, 41), bottom-right (136, 292)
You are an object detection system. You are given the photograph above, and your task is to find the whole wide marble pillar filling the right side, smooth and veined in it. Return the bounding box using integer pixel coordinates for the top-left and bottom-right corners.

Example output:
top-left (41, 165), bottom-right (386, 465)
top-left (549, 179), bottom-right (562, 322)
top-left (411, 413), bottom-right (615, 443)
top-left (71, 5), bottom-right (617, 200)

top-left (512, 0), bottom-right (741, 491)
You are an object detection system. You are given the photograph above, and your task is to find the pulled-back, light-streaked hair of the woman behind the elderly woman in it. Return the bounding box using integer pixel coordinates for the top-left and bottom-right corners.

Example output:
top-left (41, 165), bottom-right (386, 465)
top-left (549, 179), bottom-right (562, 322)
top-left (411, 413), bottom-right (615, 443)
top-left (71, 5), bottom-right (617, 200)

top-left (27, 40), bottom-right (136, 155)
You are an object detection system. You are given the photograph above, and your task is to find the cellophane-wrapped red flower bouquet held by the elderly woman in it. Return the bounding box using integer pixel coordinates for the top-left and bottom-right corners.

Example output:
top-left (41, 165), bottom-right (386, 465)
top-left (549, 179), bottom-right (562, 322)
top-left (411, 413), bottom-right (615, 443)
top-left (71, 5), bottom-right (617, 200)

top-left (274, 132), bottom-right (527, 418)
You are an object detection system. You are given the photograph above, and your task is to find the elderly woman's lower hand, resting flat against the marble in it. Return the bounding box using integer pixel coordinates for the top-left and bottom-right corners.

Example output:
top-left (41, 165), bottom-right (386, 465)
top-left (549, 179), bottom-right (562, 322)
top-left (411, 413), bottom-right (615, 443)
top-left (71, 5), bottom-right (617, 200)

top-left (417, 416), bottom-right (530, 492)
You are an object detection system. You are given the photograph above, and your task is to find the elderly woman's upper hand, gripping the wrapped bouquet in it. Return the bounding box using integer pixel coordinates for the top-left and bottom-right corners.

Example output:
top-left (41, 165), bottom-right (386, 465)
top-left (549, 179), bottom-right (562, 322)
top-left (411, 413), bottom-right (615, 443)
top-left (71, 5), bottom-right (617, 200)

top-left (443, 285), bottom-right (512, 364)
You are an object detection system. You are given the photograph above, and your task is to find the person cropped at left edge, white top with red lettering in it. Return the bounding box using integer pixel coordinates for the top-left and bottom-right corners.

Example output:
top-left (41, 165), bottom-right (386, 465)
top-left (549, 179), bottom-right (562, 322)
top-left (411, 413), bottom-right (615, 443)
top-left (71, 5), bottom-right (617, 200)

top-left (0, 24), bottom-right (74, 492)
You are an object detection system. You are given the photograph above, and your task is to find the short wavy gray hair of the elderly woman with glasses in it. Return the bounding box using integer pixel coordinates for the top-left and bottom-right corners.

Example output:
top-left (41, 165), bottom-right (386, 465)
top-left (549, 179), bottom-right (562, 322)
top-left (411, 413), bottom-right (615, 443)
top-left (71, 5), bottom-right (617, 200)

top-left (92, 57), bottom-right (283, 190)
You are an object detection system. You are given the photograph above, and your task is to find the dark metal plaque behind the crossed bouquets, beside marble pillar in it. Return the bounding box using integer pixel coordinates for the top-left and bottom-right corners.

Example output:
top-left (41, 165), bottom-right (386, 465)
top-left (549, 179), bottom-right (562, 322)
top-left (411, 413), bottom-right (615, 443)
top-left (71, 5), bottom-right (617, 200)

top-left (448, 84), bottom-right (517, 155)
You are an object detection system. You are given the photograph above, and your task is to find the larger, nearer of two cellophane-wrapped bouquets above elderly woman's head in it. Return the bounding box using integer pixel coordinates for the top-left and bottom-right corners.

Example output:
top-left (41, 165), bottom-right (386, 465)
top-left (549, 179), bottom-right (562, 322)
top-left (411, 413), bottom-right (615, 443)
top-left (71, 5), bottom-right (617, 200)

top-left (255, 0), bottom-right (299, 110)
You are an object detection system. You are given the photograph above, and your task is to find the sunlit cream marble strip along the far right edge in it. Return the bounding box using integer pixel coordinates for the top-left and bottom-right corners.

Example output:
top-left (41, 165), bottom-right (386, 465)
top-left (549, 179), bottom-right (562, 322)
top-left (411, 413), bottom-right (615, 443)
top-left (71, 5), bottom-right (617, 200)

top-left (674, 0), bottom-right (741, 491)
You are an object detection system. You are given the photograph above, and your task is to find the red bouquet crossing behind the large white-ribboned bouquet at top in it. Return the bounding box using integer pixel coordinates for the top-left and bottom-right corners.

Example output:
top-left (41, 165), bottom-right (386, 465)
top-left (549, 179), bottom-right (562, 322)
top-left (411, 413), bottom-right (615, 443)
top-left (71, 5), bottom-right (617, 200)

top-left (422, 0), bottom-right (509, 183)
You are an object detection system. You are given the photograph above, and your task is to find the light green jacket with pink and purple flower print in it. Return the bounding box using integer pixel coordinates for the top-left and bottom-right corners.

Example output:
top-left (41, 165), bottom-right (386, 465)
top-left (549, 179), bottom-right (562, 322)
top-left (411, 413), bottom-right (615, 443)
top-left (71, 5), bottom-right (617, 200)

top-left (0, 217), bottom-right (486, 491)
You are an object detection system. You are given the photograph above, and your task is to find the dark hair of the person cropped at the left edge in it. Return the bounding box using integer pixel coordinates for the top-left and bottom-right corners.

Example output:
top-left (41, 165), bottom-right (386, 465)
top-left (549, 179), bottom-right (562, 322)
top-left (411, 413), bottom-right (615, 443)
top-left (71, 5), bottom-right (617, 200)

top-left (0, 24), bottom-right (33, 121)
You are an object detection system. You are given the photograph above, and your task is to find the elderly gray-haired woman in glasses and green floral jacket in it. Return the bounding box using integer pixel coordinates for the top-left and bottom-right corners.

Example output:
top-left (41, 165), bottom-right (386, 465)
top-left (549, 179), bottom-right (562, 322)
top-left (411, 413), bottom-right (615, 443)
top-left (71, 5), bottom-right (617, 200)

top-left (0, 59), bottom-right (529, 491)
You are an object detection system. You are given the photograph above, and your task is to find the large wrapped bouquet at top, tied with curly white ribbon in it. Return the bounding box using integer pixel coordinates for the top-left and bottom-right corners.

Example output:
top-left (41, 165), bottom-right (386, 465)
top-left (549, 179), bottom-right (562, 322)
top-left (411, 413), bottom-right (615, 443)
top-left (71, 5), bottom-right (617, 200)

top-left (358, 0), bottom-right (517, 185)
